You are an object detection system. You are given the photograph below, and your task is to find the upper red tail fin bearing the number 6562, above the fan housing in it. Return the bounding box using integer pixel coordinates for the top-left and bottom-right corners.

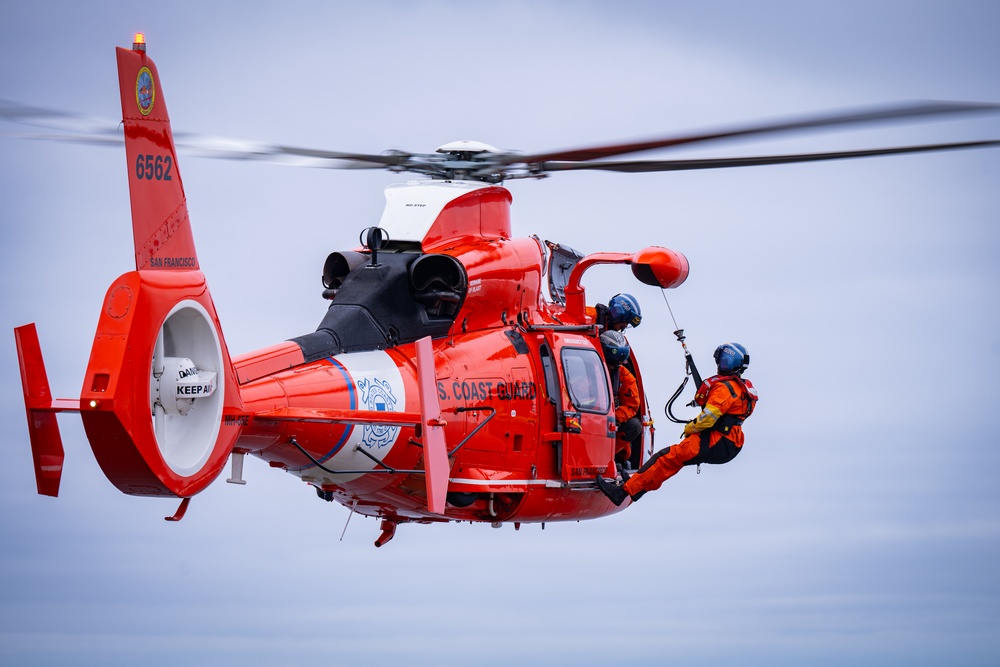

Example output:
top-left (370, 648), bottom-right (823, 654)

top-left (118, 45), bottom-right (199, 270)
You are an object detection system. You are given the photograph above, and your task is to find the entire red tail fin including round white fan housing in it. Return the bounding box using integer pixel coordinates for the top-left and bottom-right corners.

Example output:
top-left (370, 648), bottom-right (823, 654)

top-left (71, 41), bottom-right (242, 498)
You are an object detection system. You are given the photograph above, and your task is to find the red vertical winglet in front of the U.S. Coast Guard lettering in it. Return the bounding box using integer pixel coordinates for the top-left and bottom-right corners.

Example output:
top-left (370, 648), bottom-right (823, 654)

top-left (416, 336), bottom-right (451, 514)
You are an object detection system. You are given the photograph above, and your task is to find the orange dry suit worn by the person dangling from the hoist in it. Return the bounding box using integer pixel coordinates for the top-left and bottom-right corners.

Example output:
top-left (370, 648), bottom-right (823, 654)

top-left (624, 375), bottom-right (757, 498)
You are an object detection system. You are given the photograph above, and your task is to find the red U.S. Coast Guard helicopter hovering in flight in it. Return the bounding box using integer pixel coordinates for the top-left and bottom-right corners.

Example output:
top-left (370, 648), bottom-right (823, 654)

top-left (7, 36), bottom-right (1000, 546)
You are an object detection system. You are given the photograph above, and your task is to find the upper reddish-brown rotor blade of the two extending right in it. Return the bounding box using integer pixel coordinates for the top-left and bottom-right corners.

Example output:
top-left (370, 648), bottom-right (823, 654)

top-left (512, 101), bottom-right (1000, 165)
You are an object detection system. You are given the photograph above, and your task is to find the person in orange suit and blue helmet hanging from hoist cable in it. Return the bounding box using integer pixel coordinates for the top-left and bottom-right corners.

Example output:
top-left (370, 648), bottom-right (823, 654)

top-left (597, 343), bottom-right (757, 505)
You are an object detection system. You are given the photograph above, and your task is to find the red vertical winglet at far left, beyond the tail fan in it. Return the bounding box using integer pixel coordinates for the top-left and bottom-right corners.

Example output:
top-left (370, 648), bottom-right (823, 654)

top-left (14, 324), bottom-right (80, 497)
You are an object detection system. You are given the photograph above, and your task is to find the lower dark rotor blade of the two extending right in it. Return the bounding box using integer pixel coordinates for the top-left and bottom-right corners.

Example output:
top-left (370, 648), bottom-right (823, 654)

top-left (533, 140), bottom-right (1000, 175)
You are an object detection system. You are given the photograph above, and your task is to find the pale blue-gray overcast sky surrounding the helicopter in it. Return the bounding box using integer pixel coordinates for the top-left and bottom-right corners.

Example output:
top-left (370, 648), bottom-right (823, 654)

top-left (0, 0), bottom-right (1000, 666)
